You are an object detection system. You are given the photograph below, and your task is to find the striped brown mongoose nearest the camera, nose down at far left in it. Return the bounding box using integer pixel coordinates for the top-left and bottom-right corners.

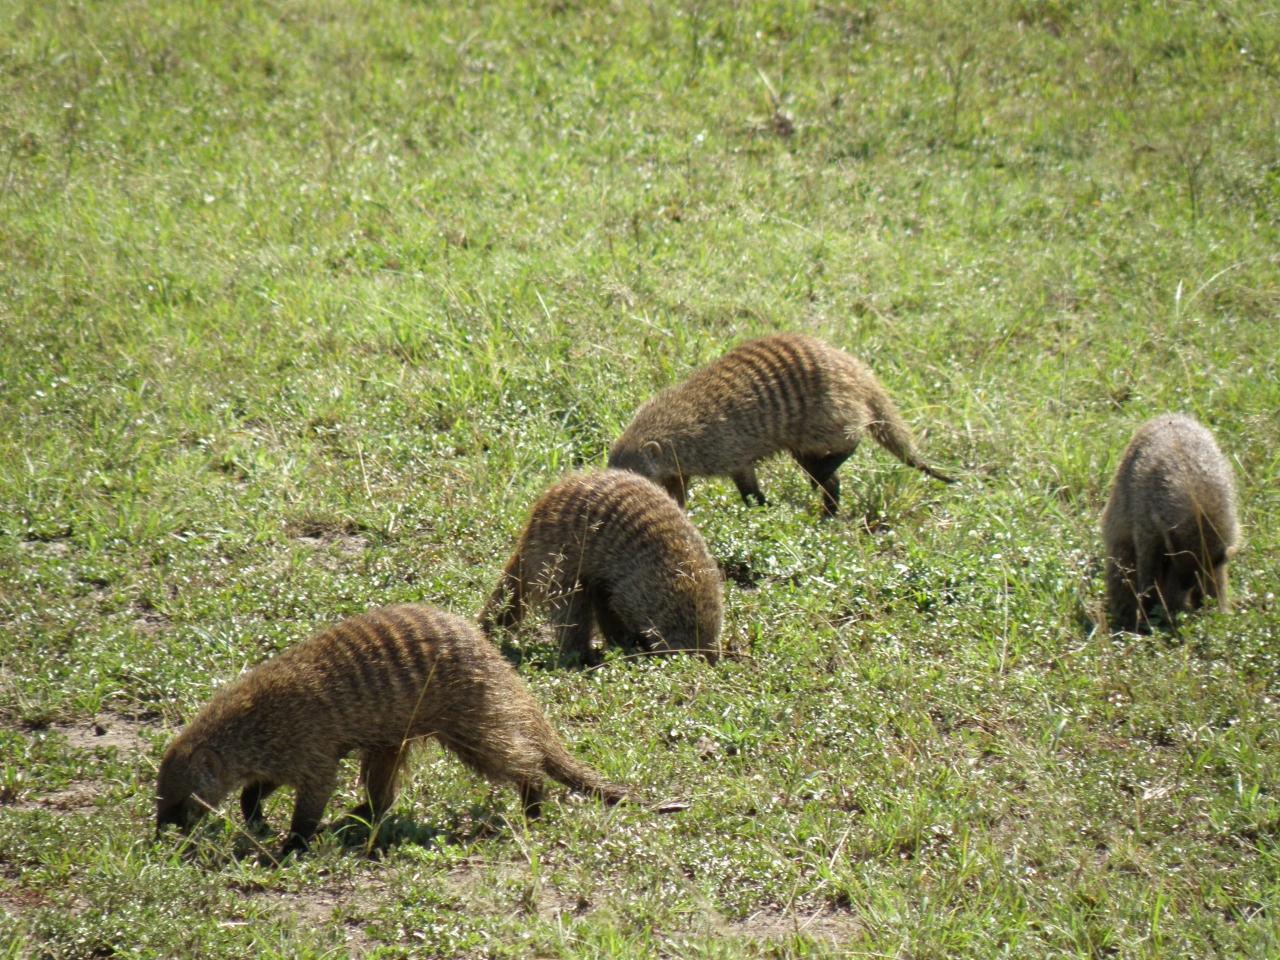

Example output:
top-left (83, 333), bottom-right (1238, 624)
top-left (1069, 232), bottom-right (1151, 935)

top-left (156, 605), bottom-right (623, 854)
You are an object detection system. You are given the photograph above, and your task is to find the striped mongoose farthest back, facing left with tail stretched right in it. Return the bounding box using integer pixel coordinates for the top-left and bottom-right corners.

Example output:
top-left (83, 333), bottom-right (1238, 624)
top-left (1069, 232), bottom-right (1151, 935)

top-left (609, 334), bottom-right (951, 516)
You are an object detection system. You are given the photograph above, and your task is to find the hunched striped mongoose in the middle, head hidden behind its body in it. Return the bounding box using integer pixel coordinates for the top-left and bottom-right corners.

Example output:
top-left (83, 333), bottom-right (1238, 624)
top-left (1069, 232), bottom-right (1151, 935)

top-left (480, 470), bottom-right (722, 664)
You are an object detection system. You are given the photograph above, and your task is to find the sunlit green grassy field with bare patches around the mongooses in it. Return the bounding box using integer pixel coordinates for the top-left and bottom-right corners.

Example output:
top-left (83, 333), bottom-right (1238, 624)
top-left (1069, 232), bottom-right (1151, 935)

top-left (0, 0), bottom-right (1280, 957)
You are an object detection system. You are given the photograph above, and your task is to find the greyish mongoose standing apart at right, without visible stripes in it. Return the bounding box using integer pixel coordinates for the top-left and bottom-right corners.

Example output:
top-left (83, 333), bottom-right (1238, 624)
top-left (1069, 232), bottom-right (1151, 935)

top-left (1102, 413), bottom-right (1240, 630)
